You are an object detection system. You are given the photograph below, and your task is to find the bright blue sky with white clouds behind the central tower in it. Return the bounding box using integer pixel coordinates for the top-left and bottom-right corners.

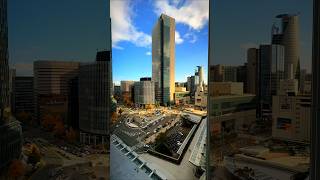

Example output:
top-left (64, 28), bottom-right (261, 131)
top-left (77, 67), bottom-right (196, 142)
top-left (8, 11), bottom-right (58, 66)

top-left (110, 0), bottom-right (209, 84)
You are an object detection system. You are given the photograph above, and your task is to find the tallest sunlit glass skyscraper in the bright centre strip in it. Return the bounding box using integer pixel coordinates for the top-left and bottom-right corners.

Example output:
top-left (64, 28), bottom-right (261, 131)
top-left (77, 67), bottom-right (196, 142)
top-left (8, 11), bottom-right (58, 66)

top-left (152, 14), bottom-right (175, 105)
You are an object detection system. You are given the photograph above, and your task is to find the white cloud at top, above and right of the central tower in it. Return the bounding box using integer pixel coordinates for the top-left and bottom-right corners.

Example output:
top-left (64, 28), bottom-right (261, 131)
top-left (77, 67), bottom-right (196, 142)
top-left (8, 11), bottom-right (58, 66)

top-left (154, 0), bottom-right (209, 30)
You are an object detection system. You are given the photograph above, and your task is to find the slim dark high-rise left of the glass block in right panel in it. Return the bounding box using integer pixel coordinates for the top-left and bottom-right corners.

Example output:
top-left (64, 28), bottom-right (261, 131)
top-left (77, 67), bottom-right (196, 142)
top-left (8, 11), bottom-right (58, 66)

top-left (247, 48), bottom-right (259, 94)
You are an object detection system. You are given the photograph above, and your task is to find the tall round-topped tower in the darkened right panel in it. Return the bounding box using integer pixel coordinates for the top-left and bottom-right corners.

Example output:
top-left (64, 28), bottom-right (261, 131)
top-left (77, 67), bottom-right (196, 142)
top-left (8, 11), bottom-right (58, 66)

top-left (272, 14), bottom-right (300, 79)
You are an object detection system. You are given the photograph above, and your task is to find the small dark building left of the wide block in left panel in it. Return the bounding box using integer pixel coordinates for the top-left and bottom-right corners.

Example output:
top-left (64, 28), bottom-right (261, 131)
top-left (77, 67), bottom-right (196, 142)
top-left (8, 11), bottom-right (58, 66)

top-left (12, 76), bottom-right (34, 115)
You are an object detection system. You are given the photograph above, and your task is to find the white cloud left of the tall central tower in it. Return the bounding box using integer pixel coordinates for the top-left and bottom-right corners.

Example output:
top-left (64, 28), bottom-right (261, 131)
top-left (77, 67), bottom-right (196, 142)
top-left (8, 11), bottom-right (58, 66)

top-left (110, 0), bottom-right (151, 49)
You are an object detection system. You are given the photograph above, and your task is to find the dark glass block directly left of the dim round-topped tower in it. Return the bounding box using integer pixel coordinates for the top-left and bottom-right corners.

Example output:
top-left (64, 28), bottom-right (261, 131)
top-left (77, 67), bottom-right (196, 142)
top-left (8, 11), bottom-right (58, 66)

top-left (259, 45), bottom-right (284, 109)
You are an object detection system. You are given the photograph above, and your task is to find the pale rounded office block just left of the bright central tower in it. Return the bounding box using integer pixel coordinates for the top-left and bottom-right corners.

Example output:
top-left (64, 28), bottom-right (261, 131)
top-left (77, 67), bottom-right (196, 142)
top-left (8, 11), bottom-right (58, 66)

top-left (134, 77), bottom-right (155, 106)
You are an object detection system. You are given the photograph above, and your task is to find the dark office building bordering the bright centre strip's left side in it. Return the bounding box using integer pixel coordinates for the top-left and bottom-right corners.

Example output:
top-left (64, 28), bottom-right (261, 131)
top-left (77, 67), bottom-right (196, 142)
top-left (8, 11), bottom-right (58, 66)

top-left (79, 51), bottom-right (112, 145)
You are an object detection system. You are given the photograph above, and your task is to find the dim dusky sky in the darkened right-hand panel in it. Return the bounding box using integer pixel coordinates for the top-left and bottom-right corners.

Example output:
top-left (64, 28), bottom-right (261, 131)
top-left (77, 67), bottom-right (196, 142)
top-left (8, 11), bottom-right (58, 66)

top-left (210, 0), bottom-right (312, 72)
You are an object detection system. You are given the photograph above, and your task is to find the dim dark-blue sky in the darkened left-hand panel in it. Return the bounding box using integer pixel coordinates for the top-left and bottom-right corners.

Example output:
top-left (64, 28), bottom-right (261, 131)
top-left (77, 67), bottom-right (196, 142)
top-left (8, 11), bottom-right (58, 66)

top-left (8, 0), bottom-right (107, 75)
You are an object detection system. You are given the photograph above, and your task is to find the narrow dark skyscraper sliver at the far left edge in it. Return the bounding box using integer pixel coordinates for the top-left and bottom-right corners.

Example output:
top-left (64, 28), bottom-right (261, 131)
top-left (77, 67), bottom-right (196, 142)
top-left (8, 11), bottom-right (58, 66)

top-left (0, 0), bottom-right (9, 121)
